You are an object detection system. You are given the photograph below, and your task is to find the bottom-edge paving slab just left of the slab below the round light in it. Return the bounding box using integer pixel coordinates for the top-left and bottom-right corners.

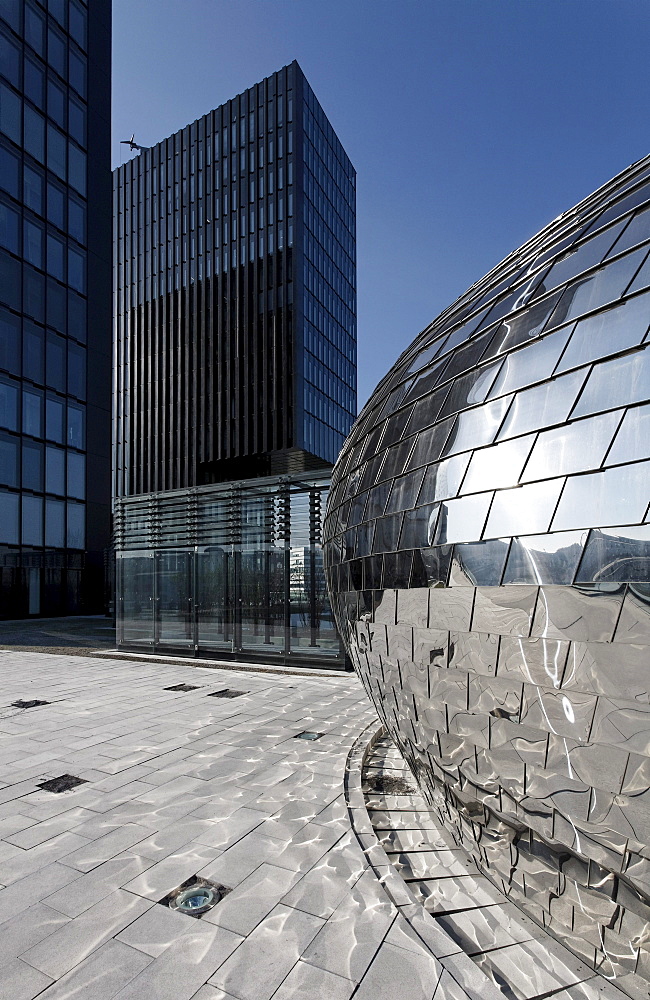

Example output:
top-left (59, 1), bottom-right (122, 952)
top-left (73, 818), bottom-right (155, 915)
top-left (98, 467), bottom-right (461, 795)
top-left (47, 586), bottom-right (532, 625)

top-left (28, 941), bottom-right (151, 1000)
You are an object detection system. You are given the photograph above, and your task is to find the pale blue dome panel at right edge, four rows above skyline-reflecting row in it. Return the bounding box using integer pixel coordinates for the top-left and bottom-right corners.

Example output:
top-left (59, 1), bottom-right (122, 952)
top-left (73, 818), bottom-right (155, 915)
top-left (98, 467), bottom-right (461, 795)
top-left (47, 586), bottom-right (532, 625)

top-left (557, 292), bottom-right (650, 372)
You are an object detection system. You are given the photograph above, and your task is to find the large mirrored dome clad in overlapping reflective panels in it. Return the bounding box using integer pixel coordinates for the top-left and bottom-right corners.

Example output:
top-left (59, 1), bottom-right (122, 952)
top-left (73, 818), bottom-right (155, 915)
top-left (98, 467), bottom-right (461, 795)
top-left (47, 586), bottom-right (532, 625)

top-left (324, 157), bottom-right (650, 997)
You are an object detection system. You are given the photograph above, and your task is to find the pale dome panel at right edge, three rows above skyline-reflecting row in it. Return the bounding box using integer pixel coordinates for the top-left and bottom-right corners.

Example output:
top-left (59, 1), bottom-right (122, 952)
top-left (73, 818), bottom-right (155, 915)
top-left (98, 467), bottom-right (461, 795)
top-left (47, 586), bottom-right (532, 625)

top-left (571, 348), bottom-right (650, 417)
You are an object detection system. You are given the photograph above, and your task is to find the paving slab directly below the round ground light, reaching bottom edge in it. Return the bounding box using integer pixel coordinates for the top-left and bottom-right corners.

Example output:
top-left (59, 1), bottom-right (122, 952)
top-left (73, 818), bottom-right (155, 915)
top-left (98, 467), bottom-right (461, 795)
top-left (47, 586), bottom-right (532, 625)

top-left (111, 917), bottom-right (243, 1000)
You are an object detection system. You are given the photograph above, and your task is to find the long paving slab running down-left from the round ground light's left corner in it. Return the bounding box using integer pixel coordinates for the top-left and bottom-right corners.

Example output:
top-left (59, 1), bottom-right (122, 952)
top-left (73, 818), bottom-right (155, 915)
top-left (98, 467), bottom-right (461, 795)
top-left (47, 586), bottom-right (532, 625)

top-left (23, 889), bottom-right (152, 979)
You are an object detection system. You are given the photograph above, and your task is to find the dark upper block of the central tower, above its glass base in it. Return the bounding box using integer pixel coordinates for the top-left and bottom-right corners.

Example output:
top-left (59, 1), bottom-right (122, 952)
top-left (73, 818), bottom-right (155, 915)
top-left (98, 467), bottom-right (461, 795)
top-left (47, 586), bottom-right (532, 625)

top-left (114, 62), bottom-right (356, 496)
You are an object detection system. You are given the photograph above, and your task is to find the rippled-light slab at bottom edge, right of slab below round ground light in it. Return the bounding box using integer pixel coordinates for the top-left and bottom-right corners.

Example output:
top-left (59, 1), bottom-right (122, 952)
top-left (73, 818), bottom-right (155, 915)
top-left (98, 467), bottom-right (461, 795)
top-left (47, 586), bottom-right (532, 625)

top-left (209, 904), bottom-right (323, 1000)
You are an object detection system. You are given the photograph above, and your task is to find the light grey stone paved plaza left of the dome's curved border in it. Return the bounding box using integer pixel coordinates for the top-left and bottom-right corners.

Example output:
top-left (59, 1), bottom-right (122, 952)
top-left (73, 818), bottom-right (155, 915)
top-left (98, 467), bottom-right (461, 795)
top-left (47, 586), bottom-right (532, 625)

top-left (0, 650), bottom-right (447, 1000)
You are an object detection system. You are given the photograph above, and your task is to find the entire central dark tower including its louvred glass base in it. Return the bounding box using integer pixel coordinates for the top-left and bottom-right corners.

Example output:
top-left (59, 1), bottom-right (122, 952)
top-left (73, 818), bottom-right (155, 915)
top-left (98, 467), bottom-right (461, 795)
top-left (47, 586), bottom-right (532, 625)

top-left (114, 62), bottom-right (356, 666)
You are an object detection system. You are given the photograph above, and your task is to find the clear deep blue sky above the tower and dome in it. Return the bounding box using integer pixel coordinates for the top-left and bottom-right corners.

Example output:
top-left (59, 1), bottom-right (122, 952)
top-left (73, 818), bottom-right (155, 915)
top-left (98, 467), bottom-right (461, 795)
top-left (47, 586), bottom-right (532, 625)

top-left (113, 0), bottom-right (650, 406)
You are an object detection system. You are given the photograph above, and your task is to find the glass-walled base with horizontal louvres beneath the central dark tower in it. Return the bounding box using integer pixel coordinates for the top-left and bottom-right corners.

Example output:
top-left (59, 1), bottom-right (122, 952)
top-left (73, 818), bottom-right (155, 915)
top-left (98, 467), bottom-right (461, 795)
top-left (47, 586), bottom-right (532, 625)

top-left (115, 474), bottom-right (345, 668)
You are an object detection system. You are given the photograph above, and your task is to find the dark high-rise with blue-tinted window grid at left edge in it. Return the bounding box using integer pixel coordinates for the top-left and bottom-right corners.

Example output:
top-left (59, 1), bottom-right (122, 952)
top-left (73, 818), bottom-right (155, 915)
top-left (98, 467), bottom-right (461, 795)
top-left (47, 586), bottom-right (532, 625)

top-left (0, 0), bottom-right (111, 618)
